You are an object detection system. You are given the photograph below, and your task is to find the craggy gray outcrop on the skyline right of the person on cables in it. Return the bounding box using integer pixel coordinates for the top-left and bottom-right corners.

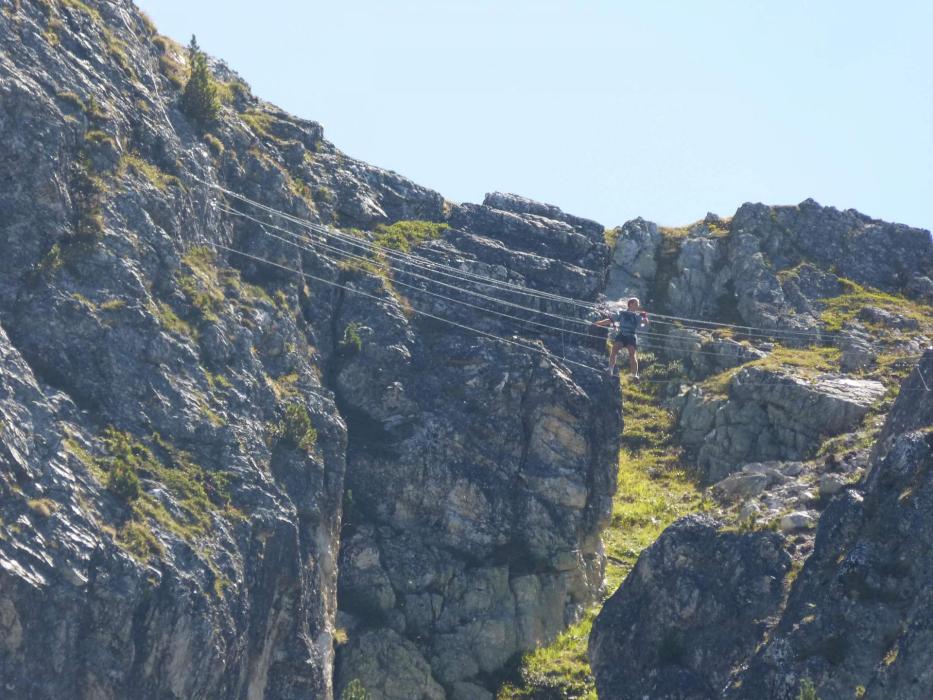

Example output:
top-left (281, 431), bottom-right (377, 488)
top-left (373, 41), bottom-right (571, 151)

top-left (666, 200), bottom-right (933, 345)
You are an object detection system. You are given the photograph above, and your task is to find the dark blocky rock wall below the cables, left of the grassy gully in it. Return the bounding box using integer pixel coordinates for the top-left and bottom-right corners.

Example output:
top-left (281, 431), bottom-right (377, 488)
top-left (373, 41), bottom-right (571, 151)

top-left (334, 232), bottom-right (619, 697)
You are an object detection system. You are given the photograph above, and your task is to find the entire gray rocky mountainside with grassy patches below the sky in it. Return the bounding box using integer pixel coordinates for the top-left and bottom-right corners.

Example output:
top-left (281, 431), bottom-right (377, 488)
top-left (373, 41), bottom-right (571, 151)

top-left (0, 0), bottom-right (933, 700)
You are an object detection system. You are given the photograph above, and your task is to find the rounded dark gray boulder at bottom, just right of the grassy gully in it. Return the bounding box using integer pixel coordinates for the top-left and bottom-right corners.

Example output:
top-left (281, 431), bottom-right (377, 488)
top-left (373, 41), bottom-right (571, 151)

top-left (589, 516), bottom-right (791, 700)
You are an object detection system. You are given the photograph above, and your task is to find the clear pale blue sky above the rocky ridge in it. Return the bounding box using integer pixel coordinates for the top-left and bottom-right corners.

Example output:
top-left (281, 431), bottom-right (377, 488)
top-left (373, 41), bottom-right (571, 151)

top-left (138, 0), bottom-right (933, 229)
